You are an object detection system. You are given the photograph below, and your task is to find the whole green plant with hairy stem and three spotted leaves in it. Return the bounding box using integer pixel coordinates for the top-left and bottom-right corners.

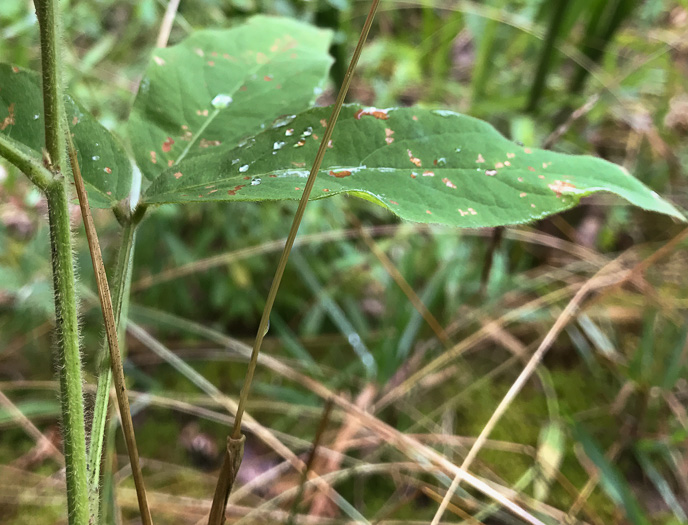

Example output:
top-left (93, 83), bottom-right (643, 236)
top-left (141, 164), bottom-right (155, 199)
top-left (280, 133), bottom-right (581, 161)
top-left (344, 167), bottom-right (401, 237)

top-left (0, 0), bottom-right (685, 523)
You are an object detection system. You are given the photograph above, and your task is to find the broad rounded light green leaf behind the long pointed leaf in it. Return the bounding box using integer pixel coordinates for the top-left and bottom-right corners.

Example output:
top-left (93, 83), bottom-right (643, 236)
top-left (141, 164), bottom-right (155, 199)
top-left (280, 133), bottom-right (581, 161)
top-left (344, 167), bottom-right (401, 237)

top-left (129, 16), bottom-right (332, 180)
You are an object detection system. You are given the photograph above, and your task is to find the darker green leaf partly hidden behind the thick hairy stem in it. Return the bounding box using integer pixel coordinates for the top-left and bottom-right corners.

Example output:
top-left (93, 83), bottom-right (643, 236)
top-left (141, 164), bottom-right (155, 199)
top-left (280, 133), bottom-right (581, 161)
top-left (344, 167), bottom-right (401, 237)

top-left (0, 64), bottom-right (132, 208)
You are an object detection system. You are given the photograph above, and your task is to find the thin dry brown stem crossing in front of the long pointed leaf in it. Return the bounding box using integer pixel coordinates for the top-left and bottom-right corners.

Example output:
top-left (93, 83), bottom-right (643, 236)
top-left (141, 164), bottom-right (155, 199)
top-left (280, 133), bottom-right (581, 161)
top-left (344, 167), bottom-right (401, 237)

top-left (208, 4), bottom-right (380, 525)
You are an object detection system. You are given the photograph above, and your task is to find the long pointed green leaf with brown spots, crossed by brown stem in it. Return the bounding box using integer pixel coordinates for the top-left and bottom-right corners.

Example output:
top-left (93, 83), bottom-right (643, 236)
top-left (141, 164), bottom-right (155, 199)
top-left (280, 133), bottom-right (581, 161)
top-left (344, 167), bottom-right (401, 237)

top-left (145, 106), bottom-right (685, 228)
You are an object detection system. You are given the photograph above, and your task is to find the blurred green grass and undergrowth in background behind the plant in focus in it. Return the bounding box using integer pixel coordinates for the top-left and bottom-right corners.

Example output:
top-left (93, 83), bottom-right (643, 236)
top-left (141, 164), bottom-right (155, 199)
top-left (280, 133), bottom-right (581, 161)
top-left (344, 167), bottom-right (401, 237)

top-left (0, 0), bottom-right (688, 524)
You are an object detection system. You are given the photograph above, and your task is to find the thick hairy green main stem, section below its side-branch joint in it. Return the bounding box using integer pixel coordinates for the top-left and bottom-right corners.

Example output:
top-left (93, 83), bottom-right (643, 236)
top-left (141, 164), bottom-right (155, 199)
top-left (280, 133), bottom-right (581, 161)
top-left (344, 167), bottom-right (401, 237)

top-left (45, 178), bottom-right (89, 525)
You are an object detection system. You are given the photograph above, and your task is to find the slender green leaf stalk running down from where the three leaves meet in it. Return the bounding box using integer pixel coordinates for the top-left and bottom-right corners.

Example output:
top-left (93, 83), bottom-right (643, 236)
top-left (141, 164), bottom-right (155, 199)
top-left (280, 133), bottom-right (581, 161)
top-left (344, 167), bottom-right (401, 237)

top-left (88, 218), bottom-right (136, 518)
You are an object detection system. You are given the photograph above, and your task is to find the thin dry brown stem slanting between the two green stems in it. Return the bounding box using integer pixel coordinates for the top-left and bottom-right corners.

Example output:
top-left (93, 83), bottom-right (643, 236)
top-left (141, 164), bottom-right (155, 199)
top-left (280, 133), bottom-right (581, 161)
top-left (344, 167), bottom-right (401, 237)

top-left (67, 135), bottom-right (153, 525)
